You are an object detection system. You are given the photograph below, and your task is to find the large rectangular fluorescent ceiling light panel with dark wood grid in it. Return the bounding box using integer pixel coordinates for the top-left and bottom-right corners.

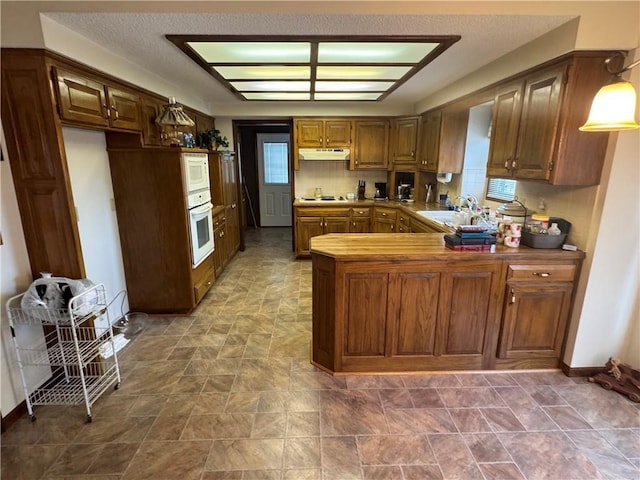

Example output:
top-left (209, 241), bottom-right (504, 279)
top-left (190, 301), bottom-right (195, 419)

top-left (167, 35), bottom-right (460, 101)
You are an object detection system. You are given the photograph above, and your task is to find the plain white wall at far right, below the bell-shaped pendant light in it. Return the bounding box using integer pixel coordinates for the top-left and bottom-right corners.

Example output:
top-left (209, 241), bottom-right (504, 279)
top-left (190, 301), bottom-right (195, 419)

top-left (568, 49), bottom-right (640, 367)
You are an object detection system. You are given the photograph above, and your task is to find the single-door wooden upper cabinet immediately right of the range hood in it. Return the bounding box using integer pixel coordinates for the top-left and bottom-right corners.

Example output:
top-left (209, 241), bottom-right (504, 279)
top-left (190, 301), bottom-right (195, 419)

top-left (349, 118), bottom-right (389, 170)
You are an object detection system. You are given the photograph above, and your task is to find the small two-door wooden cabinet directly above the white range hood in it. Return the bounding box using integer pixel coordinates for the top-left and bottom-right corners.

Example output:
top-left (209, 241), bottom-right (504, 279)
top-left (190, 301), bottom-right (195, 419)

top-left (293, 118), bottom-right (351, 148)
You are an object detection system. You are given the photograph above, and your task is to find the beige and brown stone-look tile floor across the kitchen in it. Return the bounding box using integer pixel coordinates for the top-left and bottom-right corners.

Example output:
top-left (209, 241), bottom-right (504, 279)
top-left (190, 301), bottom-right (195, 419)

top-left (2, 229), bottom-right (640, 480)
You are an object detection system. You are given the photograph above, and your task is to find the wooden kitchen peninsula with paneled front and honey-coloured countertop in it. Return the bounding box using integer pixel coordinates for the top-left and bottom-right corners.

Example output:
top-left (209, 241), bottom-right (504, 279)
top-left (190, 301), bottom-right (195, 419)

top-left (310, 233), bottom-right (584, 374)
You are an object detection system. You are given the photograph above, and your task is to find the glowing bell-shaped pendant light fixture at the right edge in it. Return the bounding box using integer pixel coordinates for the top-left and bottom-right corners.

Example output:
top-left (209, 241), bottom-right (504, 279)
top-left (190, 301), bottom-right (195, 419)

top-left (579, 53), bottom-right (640, 132)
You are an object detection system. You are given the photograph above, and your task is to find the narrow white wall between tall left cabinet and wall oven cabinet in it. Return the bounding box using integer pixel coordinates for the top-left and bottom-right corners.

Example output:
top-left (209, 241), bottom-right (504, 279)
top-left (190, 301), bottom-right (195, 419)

top-left (62, 127), bottom-right (129, 334)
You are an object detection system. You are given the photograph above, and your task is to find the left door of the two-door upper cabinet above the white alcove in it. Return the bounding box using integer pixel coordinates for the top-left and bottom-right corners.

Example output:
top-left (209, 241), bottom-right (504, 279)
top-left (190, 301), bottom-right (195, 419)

top-left (54, 68), bottom-right (109, 127)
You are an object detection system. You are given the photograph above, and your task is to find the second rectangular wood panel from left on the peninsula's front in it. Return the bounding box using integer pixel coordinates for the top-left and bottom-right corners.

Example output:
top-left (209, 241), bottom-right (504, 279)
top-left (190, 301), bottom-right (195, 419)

top-left (389, 272), bottom-right (440, 356)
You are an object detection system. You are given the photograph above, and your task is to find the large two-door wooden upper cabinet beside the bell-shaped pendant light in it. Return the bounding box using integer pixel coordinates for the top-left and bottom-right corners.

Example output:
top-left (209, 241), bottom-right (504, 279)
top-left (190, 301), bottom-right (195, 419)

top-left (487, 52), bottom-right (608, 185)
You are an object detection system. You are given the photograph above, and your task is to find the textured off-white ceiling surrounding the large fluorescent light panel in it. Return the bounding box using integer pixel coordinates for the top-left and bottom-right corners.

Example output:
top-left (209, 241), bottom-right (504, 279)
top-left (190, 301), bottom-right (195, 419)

top-left (45, 12), bottom-right (572, 108)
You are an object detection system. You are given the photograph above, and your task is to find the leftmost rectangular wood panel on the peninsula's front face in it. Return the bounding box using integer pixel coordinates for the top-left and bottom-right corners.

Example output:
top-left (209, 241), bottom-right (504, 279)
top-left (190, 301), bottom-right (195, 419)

top-left (343, 273), bottom-right (389, 357)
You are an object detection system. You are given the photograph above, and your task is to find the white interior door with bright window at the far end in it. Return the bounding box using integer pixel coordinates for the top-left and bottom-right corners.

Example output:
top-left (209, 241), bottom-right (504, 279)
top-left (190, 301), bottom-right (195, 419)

top-left (257, 133), bottom-right (292, 227)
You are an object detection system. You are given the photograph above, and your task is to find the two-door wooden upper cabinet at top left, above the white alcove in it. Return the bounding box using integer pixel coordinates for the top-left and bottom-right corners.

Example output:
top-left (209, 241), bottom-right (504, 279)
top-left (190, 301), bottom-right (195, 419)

top-left (53, 67), bottom-right (142, 131)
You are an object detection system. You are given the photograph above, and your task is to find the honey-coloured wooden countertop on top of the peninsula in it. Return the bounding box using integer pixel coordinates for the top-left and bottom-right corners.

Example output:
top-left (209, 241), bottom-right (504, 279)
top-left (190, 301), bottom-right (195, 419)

top-left (311, 233), bottom-right (584, 262)
